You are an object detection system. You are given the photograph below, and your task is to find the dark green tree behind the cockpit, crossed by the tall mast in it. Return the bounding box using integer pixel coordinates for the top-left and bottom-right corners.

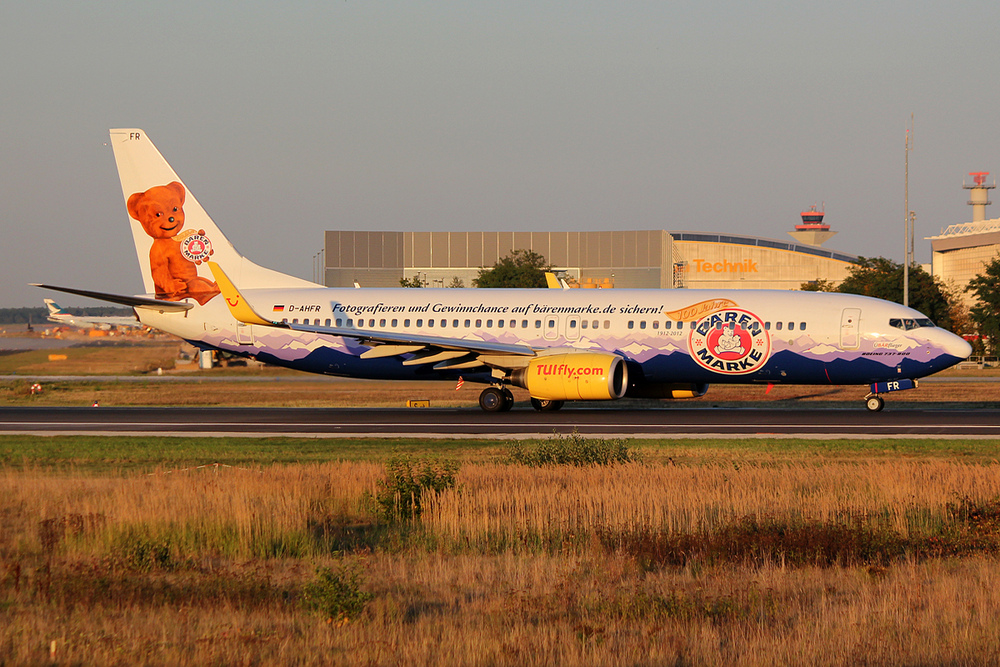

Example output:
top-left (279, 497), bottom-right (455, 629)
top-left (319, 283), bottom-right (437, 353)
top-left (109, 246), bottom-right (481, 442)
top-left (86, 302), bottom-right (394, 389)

top-left (820, 257), bottom-right (953, 330)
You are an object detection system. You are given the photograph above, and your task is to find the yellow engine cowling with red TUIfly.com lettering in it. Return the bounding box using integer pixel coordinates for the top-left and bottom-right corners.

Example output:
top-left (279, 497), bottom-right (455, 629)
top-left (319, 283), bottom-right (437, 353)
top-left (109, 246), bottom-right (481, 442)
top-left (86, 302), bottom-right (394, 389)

top-left (511, 352), bottom-right (628, 401)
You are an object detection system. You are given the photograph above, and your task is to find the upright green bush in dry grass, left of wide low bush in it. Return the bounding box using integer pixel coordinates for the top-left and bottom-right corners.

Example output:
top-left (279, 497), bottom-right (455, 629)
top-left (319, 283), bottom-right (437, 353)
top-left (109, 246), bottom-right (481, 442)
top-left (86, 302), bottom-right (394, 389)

top-left (375, 457), bottom-right (458, 521)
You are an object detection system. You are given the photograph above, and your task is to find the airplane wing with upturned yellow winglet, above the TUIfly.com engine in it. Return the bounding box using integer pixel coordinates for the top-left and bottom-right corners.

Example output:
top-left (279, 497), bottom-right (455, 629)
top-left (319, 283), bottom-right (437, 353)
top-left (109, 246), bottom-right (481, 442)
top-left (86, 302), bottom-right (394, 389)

top-left (208, 262), bottom-right (538, 370)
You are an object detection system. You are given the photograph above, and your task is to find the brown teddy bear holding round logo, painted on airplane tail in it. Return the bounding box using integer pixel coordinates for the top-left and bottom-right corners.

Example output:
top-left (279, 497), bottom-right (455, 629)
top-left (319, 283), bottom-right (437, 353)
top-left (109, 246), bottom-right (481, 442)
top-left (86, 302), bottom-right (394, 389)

top-left (128, 181), bottom-right (220, 306)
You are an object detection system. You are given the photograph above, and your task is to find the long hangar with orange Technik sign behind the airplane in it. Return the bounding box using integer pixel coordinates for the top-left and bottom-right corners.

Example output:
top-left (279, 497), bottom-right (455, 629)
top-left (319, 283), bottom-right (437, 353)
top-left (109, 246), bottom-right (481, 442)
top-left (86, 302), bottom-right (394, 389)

top-left (323, 208), bottom-right (856, 290)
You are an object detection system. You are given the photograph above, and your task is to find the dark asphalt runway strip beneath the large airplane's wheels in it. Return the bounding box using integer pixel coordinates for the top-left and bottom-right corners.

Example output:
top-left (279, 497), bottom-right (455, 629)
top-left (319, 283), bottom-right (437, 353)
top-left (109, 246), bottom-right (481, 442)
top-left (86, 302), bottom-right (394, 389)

top-left (0, 407), bottom-right (1000, 438)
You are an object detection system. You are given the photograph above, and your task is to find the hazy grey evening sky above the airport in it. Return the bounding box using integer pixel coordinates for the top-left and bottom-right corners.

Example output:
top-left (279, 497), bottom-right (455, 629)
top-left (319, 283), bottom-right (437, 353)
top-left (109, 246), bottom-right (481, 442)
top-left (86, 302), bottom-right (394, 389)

top-left (0, 0), bottom-right (1000, 307)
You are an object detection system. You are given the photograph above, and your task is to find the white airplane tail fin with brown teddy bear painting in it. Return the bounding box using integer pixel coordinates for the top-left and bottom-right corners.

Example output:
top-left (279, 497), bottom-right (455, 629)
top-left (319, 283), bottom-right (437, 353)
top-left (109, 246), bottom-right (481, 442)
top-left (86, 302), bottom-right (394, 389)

top-left (110, 129), bottom-right (316, 305)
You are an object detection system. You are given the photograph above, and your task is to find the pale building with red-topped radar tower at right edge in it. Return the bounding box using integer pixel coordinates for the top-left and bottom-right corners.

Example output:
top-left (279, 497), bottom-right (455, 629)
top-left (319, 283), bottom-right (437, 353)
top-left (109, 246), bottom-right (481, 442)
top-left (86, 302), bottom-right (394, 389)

top-left (927, 172), bottom-right (1000, 306)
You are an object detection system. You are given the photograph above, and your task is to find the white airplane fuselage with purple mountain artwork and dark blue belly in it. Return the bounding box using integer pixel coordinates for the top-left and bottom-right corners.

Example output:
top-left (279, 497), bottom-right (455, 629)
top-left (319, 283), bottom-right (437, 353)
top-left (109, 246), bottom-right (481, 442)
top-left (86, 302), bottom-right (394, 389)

top-left (140, 288), bottom-right (968, 396)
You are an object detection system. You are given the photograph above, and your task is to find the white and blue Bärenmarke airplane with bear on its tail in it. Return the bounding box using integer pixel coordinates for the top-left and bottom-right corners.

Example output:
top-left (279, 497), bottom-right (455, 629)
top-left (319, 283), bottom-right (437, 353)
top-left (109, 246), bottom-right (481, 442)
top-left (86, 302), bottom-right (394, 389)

top-left (36, 129), bottom-right (972, 412)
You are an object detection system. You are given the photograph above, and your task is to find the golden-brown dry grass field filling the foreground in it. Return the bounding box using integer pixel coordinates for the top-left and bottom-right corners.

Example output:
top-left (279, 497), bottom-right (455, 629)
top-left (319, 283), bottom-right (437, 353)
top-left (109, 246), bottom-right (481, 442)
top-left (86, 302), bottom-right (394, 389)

top-left (0, 457), bottom-right (1000, 665)
